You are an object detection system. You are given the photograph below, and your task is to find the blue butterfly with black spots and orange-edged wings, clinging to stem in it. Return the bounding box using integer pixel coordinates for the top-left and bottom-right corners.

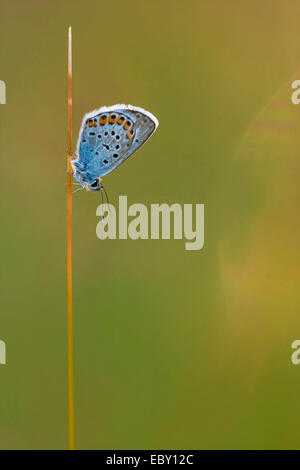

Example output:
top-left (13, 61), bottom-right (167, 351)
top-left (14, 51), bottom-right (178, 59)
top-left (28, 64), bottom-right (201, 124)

top-left (71, 104), bottom-right (158, 191)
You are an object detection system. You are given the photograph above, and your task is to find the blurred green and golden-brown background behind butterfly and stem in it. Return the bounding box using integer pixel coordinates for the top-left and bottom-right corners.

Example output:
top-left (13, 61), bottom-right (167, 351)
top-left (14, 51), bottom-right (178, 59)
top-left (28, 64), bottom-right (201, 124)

top-left (0, 0), bottom-right (300, 449)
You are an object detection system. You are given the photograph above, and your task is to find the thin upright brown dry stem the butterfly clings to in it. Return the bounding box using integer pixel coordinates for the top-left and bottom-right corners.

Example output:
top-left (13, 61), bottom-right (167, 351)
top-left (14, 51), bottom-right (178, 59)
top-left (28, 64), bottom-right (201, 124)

top-left (67, 26), bottom-right (75, 450)
